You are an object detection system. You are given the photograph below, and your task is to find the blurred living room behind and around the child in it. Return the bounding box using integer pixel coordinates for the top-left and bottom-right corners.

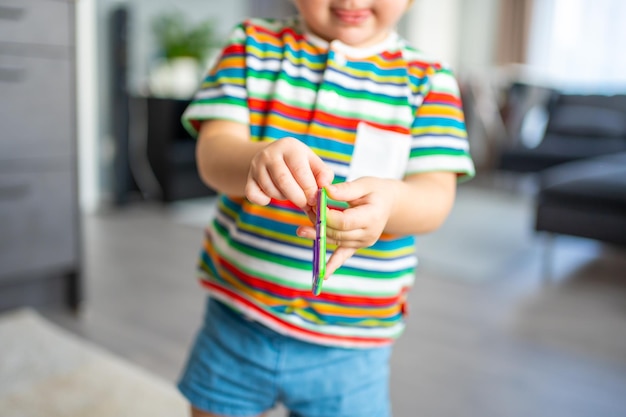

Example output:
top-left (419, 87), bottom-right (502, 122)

top-left (0, 0), bottom-right (626, 417)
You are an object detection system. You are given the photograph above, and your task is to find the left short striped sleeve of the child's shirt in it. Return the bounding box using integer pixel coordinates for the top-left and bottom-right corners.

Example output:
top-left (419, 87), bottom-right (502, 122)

top-left (182, 24), bottom-right (250, 137)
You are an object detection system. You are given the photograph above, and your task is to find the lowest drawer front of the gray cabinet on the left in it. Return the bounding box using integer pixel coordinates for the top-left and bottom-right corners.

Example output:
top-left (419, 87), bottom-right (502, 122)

top-left (0, 168), bottom-right (78, 280)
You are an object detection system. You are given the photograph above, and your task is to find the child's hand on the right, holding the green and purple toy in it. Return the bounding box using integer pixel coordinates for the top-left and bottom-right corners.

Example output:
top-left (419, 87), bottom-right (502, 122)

top-left (298, 177), bottom-right (396, 278)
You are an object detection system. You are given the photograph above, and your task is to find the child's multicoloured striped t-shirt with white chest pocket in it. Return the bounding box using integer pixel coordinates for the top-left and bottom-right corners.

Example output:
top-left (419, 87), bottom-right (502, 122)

top-left (183, 17), bottom-right (474, 347)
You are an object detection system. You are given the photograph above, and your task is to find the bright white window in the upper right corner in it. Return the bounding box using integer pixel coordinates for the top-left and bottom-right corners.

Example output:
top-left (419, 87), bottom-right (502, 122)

top-left (528, 0), bottom-right (626, 91)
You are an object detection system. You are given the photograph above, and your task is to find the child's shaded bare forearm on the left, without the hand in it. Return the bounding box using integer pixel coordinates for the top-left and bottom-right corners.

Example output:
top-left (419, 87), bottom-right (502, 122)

top-left (196, 120), bottom-right (267, 197)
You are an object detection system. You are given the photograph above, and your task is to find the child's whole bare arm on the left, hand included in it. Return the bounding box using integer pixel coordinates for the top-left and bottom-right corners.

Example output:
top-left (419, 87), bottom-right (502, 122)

top-left (196, 120), bottom-right (334, 208)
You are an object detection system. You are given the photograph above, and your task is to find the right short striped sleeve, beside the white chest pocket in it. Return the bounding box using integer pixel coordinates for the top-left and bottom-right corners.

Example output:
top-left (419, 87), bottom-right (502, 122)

top-left (407, 67), bottom-right (475, 180)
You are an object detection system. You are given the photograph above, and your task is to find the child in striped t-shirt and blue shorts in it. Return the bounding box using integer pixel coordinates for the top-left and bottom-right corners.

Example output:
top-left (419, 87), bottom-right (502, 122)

top-left (179, 0), bottom-right (474, 417)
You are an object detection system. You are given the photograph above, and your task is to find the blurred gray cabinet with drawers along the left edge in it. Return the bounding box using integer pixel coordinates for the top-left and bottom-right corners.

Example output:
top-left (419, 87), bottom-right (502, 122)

top-left (0, 0), bottom-right (81, 310)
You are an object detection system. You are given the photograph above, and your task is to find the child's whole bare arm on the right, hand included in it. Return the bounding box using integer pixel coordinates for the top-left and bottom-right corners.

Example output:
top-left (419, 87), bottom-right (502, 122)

top-left (298, 172), bottom-right (456, 277)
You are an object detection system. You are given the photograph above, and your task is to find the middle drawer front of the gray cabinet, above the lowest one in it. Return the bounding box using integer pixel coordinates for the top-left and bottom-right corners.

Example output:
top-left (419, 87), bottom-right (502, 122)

top-left (0, 55), bottom-right (74, 162)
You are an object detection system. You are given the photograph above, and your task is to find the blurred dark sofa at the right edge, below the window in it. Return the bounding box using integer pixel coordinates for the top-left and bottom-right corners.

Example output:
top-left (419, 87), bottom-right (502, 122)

top-left (498, 90), bottom-right (626, 252)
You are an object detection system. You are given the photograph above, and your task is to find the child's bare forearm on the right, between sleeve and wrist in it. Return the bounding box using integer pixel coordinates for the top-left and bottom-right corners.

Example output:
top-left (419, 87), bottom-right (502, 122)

top-left (385, 172), bottom-right (456, 235)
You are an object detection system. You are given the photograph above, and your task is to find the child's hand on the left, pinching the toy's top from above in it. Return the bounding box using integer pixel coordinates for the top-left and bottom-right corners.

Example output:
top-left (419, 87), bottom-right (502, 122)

top-left (245, 138), bottom-right (334, 211)
